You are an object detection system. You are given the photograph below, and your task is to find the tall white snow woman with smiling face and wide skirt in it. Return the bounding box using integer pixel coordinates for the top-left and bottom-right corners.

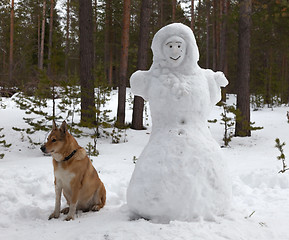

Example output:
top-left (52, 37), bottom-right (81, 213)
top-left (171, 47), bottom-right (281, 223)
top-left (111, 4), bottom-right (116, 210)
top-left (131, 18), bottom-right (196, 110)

top-left (127, 23), bottom-right (231, 222)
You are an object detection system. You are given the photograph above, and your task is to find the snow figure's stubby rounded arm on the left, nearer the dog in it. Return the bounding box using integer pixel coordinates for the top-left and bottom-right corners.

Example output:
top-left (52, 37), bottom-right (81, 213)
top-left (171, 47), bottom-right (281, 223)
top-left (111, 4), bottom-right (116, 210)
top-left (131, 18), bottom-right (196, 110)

top-left (130, 70), bottom-right (148, 101)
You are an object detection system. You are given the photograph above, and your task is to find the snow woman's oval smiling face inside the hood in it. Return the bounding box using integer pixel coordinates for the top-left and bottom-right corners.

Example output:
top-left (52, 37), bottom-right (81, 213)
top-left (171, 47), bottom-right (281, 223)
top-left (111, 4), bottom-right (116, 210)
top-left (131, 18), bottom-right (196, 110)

top-left (163, 36), bottom-right (186, 67)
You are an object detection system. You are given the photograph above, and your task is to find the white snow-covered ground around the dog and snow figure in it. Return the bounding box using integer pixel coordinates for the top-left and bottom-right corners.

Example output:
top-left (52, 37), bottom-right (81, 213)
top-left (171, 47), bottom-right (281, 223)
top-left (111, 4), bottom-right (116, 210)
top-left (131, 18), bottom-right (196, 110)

top-left (0, 91), bottom-right (289, 240)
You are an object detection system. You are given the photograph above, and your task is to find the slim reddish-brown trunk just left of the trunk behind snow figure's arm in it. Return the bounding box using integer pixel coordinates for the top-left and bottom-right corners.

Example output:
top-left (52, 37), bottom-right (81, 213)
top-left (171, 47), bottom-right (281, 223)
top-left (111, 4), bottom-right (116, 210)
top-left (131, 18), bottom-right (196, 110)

top-left (117, 0), bottom-right (130, 127)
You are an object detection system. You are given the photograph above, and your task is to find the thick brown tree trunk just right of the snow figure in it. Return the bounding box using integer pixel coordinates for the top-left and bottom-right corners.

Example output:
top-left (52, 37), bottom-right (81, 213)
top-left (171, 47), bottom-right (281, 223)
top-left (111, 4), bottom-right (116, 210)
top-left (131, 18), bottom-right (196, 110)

top-left (235, 0), bottom-right (252, 137)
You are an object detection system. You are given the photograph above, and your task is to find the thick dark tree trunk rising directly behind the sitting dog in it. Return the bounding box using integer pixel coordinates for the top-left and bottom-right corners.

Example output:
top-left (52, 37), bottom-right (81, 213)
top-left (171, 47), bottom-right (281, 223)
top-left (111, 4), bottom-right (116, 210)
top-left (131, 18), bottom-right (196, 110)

top-left (79, 0), bottom-right (96, 127)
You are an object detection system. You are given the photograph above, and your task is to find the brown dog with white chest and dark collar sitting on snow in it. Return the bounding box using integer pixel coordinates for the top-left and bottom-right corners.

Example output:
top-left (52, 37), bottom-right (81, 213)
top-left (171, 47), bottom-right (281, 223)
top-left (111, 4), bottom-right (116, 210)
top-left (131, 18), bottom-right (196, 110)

top-left (41, 121), bottom-right (106, 221)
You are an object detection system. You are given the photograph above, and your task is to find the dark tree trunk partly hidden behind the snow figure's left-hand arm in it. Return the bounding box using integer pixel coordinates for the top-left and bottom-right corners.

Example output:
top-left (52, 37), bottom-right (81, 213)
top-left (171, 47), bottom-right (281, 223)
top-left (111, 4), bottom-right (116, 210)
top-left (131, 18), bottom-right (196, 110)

top-left (131, 0), bottom-right (152, 130)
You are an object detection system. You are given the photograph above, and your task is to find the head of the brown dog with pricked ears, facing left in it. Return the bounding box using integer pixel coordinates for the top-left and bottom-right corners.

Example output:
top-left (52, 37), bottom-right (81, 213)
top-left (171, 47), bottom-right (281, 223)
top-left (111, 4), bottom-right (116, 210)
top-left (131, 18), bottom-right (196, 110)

top-left (40, 120), bottom-right (69, 155)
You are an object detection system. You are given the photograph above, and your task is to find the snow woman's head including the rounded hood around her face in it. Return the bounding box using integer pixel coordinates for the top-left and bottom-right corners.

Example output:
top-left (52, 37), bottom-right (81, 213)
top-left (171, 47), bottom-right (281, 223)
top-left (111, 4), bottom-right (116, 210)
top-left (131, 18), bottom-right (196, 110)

top-left (151, 23), bottom-right (199, 74)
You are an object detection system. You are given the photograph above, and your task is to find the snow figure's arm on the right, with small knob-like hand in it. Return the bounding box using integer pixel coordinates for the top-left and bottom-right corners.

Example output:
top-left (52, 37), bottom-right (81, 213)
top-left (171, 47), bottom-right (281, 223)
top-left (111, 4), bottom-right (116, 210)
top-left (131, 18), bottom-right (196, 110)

top-left (205, 69), bottom-right (229, 105)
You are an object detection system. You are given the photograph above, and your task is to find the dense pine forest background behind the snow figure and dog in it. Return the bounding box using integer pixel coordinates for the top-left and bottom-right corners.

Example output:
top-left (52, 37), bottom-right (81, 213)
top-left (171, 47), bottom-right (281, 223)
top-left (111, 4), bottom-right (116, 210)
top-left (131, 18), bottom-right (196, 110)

top-left (0, 0), bottom-right (289, 135)
